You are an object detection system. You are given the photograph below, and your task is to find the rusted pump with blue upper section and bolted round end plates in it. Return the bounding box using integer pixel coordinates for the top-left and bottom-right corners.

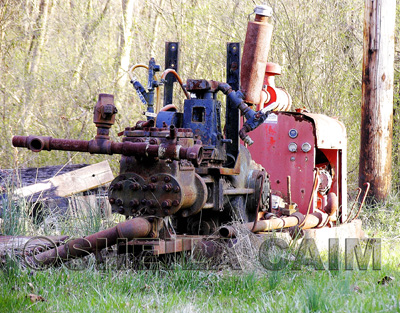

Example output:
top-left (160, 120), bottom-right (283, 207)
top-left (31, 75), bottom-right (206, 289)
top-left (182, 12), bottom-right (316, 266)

top-left (13, 80), bottom-right (269, 234)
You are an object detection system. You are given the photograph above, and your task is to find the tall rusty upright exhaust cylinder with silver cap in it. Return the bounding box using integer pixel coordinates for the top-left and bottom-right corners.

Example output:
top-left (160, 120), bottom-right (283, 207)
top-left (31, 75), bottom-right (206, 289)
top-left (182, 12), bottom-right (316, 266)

top-left (240, 6), bottom-right (273, 104)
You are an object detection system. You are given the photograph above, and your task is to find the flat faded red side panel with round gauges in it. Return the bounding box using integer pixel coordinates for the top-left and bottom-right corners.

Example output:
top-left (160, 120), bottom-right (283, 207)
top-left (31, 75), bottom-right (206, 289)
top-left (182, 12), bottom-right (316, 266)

top-left (248, 112), bottom-right (316, 214)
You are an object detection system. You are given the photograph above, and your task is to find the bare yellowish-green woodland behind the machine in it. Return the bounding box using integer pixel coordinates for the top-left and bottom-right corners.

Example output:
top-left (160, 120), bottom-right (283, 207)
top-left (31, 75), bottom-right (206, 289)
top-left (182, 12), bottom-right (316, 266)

top-left (0, 0), bottom-right (400, 191)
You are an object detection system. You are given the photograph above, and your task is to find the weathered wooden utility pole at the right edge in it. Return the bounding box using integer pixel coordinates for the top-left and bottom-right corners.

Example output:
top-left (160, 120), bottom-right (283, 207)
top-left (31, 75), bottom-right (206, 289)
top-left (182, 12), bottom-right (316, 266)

top-left (359, 0), bottom-right (396, 201)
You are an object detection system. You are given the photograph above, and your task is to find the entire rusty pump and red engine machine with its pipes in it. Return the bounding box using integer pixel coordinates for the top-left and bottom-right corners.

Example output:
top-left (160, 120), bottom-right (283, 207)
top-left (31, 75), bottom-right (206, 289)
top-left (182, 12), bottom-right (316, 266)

top-left (12, 5), bottom-right (368, 261)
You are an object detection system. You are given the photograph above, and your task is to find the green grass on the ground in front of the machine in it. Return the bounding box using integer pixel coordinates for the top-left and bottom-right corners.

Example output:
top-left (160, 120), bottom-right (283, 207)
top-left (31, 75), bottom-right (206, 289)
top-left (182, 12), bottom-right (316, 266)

top-left (0, 191), bottom-right (400, 312)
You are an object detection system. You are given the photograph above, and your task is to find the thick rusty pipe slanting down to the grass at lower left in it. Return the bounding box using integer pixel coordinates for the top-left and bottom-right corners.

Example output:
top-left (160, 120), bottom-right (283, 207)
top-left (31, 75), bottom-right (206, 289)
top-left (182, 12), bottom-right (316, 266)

top-left (30, 217), bottom-right (152, 266)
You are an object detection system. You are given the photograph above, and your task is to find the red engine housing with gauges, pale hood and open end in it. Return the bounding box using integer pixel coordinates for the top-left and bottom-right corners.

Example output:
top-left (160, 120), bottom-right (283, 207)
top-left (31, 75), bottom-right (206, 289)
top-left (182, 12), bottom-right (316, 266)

top-left (249, 112), bottom-right (347, 221)
